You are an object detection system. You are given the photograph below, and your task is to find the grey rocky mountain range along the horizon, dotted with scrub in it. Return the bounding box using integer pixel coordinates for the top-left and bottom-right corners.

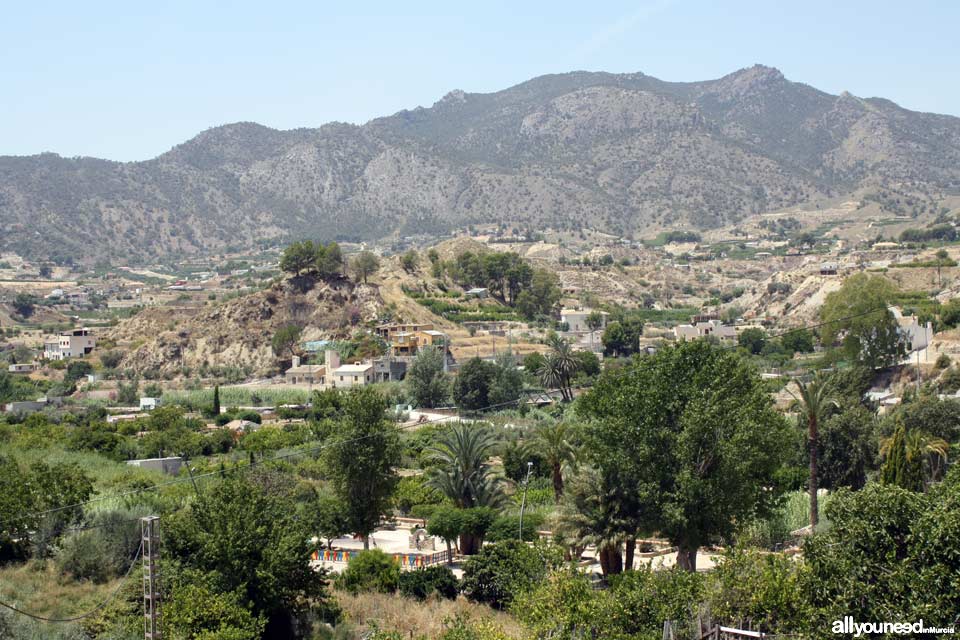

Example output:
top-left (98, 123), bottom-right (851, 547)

top-left (0, 65), bottom-right (960, 261)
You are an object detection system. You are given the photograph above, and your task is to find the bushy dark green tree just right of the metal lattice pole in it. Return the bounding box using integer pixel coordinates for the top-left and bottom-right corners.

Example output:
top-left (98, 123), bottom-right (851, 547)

top-left (164, 476), bottom-right (326, 628)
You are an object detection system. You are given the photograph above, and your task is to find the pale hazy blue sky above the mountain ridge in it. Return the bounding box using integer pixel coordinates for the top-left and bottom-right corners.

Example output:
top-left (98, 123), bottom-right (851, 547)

top-left (0, 0), bottom-right (960, 160)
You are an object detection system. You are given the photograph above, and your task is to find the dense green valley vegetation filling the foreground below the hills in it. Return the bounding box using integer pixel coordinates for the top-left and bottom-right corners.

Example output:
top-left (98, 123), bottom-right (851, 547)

top-left (0, 337), bottom-right (960, 640)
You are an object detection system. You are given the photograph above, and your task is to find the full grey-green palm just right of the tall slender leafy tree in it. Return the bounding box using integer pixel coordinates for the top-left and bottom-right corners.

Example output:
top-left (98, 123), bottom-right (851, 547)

top-left (426, 423), bottom-right (504, 509)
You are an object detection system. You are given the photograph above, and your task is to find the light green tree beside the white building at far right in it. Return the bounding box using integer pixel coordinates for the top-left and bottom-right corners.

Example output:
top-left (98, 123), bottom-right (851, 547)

top-left (820, 273), bottom-right (906, 369)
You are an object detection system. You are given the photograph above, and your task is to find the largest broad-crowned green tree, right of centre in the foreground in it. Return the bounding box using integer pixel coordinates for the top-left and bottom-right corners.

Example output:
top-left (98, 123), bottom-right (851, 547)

top-left (580, 340), bottom-right (787, 570)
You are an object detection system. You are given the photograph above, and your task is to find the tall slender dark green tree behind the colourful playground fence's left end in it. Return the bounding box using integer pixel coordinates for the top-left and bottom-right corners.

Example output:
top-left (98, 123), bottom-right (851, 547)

top-left (325, 387), bottom-right (401, 549)
